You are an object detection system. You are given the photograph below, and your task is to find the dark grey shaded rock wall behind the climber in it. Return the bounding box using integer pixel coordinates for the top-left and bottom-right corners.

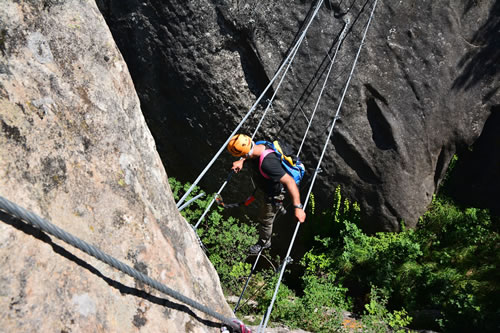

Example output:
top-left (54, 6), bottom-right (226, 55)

top-left (97, 0), bottom-right (500, 230)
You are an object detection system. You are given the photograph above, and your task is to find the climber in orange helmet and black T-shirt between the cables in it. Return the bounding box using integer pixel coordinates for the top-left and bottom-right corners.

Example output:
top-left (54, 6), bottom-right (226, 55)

top-left (227, 134), bottom-right (306, 254)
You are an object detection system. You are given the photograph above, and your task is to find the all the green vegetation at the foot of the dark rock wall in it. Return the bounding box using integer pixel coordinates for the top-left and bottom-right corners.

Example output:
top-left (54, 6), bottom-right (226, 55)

top-left (171, 180), bottom-right (500, 332)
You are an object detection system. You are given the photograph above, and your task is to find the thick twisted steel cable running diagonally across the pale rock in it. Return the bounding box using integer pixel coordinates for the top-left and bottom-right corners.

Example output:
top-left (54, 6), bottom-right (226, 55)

top-left (0, 196), bottom-right (251, 333)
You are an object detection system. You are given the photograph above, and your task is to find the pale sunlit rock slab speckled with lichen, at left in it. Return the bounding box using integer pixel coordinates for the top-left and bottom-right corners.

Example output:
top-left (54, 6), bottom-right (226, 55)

top-left (0, 0), bottom-right (232, 332)
